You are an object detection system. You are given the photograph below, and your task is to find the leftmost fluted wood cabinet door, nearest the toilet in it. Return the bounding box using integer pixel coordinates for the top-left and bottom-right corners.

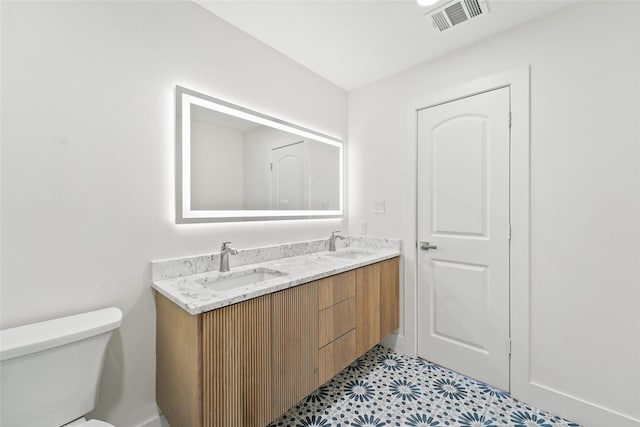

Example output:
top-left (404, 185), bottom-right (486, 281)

top-left (202, 295), bottom-right (271, 427)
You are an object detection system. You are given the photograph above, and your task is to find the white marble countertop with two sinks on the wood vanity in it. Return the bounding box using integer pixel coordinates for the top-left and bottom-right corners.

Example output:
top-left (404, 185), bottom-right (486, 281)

top-left (152, 239), bottom-right (400, 315)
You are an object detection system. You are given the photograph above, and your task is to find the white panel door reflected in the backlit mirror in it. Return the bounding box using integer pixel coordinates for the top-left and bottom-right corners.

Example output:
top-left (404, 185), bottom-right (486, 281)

top-left (271, 141), bottom-right (309, 210)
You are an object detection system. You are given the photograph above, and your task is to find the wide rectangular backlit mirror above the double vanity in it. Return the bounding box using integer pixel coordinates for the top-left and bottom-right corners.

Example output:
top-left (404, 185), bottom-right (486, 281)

top-left (176, 86), bottom-right (343, 223)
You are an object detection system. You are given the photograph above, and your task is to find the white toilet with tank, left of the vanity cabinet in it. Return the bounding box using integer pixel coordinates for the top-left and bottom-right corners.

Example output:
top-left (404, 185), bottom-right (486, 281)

top-left (0, 307), bottom-right (122, 427)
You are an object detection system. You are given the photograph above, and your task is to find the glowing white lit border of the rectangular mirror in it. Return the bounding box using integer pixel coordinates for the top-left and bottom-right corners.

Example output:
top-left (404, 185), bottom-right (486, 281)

top-left (175, 85), bottom-right (344, 224)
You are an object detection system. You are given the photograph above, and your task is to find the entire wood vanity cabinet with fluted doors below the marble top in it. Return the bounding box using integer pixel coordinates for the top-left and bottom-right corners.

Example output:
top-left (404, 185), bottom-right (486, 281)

top-left (156, 258), bottom-right (399, 427)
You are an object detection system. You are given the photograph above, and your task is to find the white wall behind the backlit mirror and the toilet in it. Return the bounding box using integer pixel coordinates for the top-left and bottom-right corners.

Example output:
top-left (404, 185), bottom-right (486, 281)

top-left (0, 2), bottom-right (346, 427)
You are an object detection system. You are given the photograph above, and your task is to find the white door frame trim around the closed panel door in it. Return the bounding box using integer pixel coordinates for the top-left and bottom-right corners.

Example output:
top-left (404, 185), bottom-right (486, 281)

top-left (407, 65), bottom-right (537, 401)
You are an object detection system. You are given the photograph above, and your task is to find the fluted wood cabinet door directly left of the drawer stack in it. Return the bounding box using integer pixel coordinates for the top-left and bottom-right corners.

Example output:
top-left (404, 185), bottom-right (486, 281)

top-left (271, 282), bottom-right (318, 418)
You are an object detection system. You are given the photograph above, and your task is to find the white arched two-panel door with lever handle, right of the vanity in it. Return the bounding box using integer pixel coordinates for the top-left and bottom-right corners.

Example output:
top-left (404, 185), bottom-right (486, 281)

top-left (417, 88), bottom-right (509, 390)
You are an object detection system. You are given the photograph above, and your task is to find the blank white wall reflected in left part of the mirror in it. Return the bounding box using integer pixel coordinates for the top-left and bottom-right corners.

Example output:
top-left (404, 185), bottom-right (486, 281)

top-left (191, 119), bottom-right (244, 210)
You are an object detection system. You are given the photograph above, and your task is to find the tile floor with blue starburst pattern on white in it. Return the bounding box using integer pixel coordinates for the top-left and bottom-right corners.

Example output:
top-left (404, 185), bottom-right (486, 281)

top-left (269, 346), bottom-right (580, 427)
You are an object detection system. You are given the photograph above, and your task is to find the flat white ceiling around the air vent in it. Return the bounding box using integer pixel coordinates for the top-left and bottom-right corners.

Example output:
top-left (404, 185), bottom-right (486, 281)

top-left (193, 0), bottom-right (575, 91)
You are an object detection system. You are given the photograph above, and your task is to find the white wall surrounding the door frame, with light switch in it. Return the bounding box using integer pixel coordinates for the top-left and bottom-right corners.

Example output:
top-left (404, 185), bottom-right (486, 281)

top-left (347, 2), bottom-right (640, 426)
